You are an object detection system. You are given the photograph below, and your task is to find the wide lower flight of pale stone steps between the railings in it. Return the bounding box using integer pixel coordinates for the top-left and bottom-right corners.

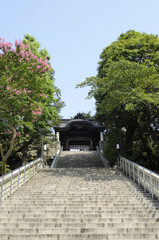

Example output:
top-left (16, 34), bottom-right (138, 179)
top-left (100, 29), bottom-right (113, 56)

top-left (0, 153), bottom-right (159, 240)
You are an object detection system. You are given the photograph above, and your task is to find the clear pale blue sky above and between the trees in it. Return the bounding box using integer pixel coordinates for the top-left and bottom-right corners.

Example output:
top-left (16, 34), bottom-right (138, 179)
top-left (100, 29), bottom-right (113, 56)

top-left (0, 0), bottom-right (159, 118)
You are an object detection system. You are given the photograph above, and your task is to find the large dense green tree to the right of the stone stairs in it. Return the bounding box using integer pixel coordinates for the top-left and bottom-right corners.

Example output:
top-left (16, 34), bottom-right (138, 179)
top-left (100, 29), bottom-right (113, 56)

top-left (79, 30), bottom-right (159, 167)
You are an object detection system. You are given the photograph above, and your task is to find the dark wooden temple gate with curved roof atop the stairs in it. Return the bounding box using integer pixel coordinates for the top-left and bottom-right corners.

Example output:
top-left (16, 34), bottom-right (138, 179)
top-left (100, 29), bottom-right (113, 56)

top-left (54, 114), bottom-right (105, 151)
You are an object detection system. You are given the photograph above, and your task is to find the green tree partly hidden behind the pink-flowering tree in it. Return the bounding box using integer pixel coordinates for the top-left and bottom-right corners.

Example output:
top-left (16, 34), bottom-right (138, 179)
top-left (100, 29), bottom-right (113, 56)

top-left (16, 34), bottom-right (64, 163)
